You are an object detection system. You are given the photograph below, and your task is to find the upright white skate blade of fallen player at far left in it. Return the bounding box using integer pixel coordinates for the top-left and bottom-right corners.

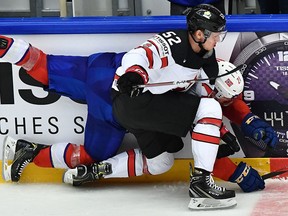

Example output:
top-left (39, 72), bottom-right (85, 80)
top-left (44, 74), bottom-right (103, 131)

top-left (2, 136), bottom-right (17, 181)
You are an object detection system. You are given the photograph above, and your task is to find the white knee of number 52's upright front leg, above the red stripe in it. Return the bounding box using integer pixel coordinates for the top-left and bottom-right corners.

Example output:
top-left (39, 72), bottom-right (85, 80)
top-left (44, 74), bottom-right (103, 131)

top-left (195, 98), bottom-right (222, 122)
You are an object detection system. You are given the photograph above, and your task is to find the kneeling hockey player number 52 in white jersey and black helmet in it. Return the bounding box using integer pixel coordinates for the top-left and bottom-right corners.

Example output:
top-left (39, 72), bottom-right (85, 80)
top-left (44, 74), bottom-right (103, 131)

top-left (64, 5), bottom-right (236, 209)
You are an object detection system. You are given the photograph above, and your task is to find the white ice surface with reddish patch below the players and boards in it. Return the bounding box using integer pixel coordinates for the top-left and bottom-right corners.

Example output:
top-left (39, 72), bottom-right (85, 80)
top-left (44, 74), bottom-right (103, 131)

top-left (0, 179), bottom-right (288, 216)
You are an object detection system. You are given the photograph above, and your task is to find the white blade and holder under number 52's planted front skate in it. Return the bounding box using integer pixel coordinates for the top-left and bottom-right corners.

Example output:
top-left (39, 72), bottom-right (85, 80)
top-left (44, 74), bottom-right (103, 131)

top-left (188, 197), bottom-right (237, 210)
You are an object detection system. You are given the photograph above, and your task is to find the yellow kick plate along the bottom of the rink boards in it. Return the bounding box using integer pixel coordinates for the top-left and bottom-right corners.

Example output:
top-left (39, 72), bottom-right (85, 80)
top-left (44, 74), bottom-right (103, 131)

top-left (0, 158), bottom-right (288, 183)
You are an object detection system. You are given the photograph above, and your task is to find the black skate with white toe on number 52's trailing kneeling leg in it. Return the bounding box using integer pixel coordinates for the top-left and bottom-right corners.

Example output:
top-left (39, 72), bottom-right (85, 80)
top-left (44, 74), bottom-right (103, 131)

top-left (63, 162), bottom-right (112, 186)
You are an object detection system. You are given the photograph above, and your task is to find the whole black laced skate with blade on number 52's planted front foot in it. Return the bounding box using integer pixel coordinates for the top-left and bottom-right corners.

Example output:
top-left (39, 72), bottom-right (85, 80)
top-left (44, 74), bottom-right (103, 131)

top-left (188, 168), bottom-right (237, 210)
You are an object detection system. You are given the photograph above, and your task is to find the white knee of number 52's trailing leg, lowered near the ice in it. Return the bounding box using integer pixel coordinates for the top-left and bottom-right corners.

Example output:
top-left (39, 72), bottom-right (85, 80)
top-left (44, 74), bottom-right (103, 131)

top-left (147, 152), bottom-right (174, 175)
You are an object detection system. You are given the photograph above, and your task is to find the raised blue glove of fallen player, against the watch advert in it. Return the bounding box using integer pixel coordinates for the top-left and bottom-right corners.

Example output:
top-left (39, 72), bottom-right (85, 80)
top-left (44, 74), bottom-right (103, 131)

top-left (241, 113), bottom-right (277, 148)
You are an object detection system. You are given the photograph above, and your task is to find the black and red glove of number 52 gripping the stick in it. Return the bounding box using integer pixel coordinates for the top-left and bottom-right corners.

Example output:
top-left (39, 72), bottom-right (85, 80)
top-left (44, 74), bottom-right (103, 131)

top-left (117, 65), bottom-right (148, 97)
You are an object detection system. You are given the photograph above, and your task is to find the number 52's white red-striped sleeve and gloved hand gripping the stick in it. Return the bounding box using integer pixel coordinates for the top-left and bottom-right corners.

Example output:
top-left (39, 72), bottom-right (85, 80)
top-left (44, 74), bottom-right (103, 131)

top-left (115, 34), bottom-right (174, 96)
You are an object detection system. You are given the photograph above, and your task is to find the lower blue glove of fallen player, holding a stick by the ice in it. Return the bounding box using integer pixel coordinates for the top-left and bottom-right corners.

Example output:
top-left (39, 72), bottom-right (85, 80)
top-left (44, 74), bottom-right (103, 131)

top-left (229, 162), bottom-right (265, 192)
